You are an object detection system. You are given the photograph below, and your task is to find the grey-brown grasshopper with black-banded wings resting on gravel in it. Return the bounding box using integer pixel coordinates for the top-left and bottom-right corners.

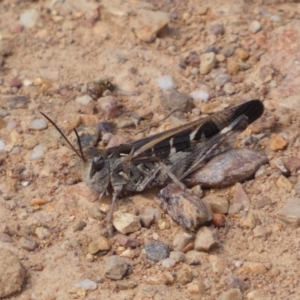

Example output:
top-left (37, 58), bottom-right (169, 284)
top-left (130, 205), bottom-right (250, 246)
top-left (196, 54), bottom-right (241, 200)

top-left (42, 100), bottom-right (264, 232)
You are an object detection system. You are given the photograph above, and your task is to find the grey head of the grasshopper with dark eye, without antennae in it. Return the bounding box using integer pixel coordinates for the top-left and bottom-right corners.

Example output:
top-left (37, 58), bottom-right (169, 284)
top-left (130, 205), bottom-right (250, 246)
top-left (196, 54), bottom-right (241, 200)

top-left (81, 147), bottom-right (110, 193)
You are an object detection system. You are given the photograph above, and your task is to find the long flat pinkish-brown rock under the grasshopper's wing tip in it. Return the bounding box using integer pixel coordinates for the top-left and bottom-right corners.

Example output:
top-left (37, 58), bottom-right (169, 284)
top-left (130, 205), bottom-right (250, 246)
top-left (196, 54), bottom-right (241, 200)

top-left (191, 148), bottom-right (268, 187)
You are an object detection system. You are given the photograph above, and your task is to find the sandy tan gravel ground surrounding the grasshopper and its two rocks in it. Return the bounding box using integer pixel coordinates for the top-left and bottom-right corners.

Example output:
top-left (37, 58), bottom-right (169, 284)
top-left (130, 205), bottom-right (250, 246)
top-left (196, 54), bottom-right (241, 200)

top-left (0, 0), bottom-right (300, 300)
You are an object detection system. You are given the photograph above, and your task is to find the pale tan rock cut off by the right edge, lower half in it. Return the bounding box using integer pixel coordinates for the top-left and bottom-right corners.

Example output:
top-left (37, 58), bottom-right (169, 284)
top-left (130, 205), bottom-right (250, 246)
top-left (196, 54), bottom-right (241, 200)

top-left (277, 198), bottom-right (300, 226)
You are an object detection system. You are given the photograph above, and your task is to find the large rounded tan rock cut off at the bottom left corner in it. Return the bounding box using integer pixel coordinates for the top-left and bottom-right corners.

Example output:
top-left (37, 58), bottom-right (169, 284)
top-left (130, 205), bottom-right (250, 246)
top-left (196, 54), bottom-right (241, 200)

top-left (0, 249), bottom-right (26, 299)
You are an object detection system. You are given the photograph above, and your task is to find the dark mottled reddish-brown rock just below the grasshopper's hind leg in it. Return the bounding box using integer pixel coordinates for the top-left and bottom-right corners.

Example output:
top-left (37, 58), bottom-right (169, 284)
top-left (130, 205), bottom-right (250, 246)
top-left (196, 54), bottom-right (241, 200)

top-left (156, 184), bottom-right (212, 231)
